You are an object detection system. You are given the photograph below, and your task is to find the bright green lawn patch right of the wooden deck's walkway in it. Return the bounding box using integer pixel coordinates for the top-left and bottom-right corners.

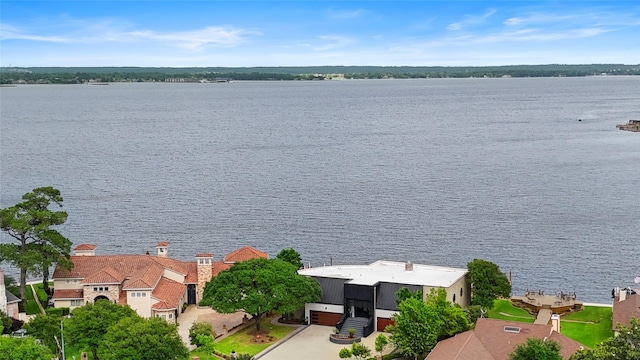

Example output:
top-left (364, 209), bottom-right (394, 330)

top-left (560, 306), bottom-right (613, 348)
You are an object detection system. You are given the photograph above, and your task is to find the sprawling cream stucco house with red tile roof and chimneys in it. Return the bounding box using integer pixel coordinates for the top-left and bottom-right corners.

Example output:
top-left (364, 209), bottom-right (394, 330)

top-left (51, 241), bottom-right (268, 322)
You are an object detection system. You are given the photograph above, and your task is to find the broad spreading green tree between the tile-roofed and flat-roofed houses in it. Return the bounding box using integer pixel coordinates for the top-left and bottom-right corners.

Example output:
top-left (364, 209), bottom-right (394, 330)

top-left (200, 258), bottom-right (322, 331)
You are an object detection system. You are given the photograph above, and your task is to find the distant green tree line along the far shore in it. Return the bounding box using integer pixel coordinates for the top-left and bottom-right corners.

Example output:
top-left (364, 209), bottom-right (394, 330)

top-left (0, 64), bottom-right (640, 84)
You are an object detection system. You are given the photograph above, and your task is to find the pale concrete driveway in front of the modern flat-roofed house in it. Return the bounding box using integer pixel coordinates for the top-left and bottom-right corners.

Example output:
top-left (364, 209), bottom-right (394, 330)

top-left (255, 325), bottom-right (391, 360)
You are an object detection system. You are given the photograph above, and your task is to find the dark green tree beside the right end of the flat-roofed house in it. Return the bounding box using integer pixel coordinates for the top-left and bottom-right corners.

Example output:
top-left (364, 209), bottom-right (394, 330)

top-left (467, 259), bottom-right (511, 309)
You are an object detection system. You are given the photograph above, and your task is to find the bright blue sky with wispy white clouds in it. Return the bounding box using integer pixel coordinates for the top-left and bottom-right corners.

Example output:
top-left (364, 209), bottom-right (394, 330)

top-left (0, 0), bottom-right (640, 67)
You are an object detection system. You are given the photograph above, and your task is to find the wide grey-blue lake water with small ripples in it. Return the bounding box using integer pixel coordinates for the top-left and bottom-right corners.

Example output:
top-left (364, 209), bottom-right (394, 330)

top-left (0, 77), bottom-right (640, 302)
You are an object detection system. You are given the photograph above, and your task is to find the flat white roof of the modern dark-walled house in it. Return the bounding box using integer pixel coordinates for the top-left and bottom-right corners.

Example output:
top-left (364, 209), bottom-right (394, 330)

top-left (298, 260), bottom-right (467, 288)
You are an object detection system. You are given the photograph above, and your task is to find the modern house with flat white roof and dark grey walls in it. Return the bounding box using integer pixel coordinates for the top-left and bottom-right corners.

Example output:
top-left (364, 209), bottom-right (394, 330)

top-left (298, 260), bottom-right (471, 336)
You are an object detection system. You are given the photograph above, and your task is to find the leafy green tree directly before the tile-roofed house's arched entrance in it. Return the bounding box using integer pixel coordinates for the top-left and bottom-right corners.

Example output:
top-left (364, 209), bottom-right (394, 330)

top-left (64, 300), bottom-right (138, 360)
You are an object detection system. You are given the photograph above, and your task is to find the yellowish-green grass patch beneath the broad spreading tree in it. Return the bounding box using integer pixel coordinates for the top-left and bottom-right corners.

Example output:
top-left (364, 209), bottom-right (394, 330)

top-left (214, 317), bottom-right (295, 356)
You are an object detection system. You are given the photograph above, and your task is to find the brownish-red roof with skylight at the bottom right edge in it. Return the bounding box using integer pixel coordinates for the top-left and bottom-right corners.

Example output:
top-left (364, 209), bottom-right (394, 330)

top-left (427, 319), bottom-right (583, 360)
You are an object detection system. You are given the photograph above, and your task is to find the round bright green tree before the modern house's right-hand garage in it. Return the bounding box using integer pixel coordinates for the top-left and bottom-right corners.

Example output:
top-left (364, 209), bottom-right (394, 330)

top-left (386, 297), bottom-right (442, 359)
